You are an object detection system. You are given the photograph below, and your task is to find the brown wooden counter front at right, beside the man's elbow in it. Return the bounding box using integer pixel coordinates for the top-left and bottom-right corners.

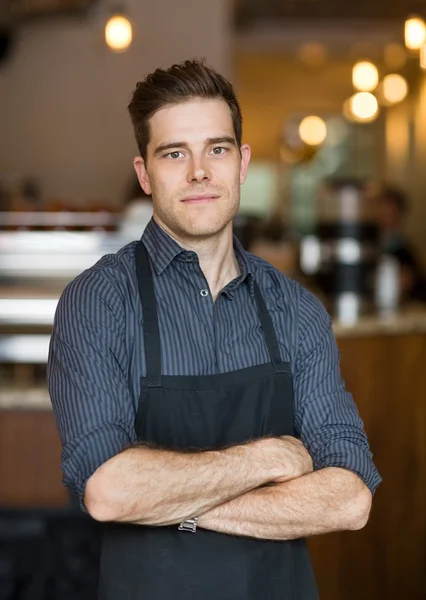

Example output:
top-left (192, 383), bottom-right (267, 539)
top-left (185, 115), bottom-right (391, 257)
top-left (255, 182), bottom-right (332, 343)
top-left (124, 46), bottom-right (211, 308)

top-left (309, 333), bottom-right (426, 600)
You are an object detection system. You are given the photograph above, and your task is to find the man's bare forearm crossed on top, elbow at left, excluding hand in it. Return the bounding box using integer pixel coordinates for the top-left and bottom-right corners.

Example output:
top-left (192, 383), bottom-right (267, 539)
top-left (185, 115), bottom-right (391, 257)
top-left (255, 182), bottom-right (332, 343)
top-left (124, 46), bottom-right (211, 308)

top-left (84, 442), bottom-right (273, 525)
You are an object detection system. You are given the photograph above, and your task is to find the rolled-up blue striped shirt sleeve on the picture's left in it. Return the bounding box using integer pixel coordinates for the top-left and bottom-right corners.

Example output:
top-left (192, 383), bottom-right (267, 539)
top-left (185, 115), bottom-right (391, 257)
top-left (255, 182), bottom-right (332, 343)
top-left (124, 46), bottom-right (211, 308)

top-left (47, 270), bottom-right (136, 509)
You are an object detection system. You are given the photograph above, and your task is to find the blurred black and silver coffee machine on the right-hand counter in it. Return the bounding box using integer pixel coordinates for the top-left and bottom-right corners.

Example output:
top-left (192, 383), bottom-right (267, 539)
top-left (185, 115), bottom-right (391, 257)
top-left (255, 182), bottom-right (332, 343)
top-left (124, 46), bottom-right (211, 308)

top-left (300, 179), bottom-right (379, 323)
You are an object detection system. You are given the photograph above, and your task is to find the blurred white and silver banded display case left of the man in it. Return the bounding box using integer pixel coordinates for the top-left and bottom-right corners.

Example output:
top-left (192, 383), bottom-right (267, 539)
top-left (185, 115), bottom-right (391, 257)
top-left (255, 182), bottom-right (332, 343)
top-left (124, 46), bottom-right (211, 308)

top-left (0, 213), bottom-right (128, 408)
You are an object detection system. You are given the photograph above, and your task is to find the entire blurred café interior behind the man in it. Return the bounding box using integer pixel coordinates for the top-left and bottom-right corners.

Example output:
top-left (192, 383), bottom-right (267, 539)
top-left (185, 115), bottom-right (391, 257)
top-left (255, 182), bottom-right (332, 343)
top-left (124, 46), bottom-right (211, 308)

top-left (0, 0), bottom-right (426, 600)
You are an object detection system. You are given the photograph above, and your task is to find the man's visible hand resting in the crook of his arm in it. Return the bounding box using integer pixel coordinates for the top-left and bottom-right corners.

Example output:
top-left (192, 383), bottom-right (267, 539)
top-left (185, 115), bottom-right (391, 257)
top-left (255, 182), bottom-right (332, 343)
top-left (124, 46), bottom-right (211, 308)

top-left (262, 435), bottom-right (313, 483)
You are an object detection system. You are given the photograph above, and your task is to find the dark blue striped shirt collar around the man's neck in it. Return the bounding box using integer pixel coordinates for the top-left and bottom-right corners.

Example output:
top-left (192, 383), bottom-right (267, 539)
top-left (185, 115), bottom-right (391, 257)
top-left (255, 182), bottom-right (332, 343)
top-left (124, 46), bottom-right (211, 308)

top-left (141, 218), bottom-right (254, 297)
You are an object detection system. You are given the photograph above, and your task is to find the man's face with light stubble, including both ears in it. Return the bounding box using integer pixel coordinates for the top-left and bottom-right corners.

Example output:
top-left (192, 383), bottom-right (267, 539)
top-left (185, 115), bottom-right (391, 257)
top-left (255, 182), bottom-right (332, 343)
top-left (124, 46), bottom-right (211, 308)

top-left (134, 99), bottom-right (250, 240)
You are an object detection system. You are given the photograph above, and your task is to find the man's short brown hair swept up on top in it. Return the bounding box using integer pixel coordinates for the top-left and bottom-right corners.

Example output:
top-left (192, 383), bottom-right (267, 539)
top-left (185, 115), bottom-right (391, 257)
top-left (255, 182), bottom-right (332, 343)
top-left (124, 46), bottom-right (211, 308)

top-left (128, 60), bottom-right (242, 162)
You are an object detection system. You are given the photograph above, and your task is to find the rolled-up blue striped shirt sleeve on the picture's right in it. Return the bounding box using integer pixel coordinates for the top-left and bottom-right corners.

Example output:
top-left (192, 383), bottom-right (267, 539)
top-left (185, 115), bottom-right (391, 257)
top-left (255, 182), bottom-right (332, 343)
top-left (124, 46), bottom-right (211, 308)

top-left (294, 288), bottom-right (381, 494)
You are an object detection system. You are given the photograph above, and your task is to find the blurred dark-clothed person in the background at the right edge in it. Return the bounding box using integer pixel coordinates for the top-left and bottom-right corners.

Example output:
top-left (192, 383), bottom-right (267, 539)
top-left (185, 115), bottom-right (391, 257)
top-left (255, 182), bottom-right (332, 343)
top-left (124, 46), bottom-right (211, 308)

top-left (377, 186), bottom-right (426, 301)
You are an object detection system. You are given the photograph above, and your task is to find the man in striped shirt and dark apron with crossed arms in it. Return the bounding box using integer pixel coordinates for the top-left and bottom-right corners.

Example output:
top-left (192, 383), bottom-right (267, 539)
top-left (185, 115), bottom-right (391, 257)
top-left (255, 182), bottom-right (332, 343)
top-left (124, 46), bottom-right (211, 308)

top-left (48, 61), bottom-right (380, 600)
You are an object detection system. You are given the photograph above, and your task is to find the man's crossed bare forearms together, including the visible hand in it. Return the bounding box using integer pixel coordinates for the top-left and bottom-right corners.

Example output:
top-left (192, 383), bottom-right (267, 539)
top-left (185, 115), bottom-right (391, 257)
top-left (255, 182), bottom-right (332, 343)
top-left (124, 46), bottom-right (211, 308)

top-left (84, 436), bottom-right (372, 540)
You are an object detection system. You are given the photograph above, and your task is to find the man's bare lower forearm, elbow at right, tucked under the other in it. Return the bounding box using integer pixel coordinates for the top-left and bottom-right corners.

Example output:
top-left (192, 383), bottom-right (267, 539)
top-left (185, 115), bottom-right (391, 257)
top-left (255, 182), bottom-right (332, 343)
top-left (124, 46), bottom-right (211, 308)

top-left (198, 468), bottom-right (371, 540)
